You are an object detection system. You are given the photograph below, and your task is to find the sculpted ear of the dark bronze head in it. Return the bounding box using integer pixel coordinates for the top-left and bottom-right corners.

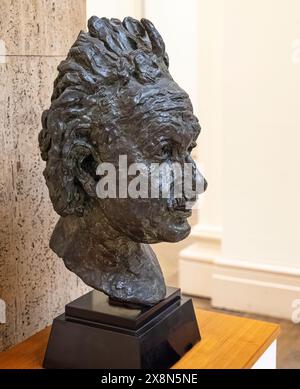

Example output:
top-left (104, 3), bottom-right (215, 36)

top-left (66, 139), bottom-right (100, 197)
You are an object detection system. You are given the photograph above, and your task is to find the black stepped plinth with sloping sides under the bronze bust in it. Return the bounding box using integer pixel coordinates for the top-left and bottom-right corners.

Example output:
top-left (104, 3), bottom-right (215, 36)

top-left (43, 288), bottom-right (200, 369)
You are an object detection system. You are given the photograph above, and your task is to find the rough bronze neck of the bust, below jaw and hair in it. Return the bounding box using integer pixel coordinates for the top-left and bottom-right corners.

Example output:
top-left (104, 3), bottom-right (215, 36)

top-left (50, 202), bottom-right (165, 305)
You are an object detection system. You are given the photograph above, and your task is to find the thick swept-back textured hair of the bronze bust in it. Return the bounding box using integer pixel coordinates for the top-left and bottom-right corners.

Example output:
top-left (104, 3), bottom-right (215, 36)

top-left (39, 16), bottom-right (187, 216)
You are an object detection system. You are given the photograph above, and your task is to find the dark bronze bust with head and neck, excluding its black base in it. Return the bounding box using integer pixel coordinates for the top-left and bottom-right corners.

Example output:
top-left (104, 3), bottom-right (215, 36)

top-left (39, 16), bottom-right (206, 305)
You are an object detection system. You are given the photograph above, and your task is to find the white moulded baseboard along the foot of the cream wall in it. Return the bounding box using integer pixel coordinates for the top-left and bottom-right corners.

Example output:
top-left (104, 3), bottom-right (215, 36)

top-left (179, 242), bottom-right (300, 319)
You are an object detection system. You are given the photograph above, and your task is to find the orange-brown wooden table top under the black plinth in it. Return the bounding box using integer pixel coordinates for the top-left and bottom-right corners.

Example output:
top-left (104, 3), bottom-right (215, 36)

top-left (0, 309), bottom-right (280, 369)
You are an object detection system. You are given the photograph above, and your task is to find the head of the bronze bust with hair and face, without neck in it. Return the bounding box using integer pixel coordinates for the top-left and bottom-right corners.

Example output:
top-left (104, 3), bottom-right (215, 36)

top-left (39, 17), bottom-right (206, 243)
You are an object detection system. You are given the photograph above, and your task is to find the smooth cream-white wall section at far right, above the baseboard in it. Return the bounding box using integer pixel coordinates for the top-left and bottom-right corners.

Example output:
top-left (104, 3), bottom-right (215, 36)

top-left (223, 0), bottom-right (300, 267)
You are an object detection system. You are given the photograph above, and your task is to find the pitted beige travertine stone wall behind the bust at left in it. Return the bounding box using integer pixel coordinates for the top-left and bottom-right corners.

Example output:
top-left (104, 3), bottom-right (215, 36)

top-left (0, 0), bottom-right (87, 350)
